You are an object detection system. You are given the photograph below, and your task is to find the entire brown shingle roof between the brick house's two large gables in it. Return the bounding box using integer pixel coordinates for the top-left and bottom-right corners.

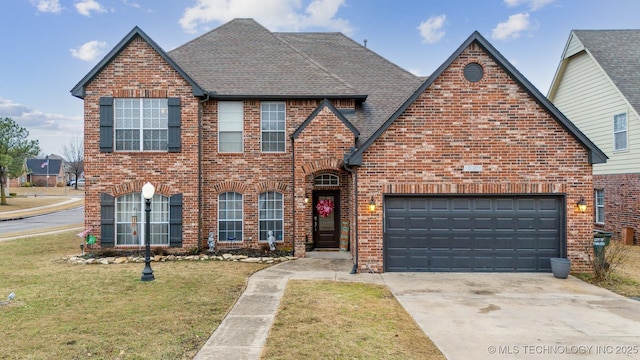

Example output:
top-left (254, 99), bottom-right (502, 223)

top-left (169, 19), bottom-right (422, 141)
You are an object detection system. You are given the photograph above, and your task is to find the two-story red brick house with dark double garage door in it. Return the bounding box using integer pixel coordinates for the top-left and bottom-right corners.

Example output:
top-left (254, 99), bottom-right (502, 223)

top-left (71, 19), bottom-right (606, 272)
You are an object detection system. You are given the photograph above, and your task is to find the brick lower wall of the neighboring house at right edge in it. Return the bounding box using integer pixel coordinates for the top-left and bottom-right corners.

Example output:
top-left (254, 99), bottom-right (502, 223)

top-left (592, 173), bottom-right (640, 244)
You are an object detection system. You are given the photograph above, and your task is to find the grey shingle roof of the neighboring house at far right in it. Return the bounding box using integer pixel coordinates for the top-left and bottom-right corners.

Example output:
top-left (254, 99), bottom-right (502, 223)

top-left (573, 30), bottom-right (640, 113)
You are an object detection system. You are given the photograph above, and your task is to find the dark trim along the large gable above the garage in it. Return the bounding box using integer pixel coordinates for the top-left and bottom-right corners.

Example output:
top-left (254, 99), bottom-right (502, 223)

top-left (346, 31), bottom-right (607, 165)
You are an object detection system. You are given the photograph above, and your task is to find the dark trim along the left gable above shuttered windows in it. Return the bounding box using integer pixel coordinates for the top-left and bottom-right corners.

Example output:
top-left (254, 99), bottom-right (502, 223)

top-left (71, 26), bottom-right (206, 99)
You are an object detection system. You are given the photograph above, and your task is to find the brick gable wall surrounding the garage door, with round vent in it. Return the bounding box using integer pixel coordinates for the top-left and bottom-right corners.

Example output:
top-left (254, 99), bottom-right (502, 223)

top-left (358, 45), bottom-right (593, 271)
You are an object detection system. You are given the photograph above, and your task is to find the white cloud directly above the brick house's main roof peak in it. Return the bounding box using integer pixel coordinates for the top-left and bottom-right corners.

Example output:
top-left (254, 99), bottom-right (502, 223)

top-left (179, 0), bottom-right (352, 34)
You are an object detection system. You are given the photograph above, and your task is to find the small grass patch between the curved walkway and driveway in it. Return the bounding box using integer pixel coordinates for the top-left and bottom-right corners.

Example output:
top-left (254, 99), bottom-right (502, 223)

top-left (262, 280), bottom-right (445, 360)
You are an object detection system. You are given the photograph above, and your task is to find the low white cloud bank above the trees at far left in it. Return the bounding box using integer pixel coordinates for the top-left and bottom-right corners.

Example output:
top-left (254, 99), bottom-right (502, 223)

top-left (0, 97), bottom-right (84, 155)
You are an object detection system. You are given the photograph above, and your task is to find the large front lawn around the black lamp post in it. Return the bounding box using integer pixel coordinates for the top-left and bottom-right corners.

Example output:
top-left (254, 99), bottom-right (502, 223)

top-left (0, 233), bottom-right (265, 359)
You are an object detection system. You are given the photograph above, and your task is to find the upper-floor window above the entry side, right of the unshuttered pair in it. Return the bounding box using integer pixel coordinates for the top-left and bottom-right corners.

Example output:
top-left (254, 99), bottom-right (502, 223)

top-left (260, 101), bottom-right (287, 153)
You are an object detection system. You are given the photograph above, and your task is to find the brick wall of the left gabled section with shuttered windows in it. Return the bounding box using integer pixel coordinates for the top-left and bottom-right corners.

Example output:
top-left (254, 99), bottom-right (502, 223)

top-left (84, 37), bottom-right (199, 249)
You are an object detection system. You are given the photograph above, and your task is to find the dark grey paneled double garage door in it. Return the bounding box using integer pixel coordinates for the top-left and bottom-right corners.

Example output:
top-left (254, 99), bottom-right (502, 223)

top-left (384, 196), bottom-right (565, 272)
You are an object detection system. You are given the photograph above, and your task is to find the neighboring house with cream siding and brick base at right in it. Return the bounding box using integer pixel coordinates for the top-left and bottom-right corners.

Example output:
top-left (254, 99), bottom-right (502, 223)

top-left (548, 30), bottom-right (640, 244)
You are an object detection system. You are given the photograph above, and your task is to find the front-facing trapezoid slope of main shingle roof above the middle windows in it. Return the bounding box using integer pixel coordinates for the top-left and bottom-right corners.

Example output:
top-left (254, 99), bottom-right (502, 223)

top-left (169, 19), bottom-right (363, 98)
